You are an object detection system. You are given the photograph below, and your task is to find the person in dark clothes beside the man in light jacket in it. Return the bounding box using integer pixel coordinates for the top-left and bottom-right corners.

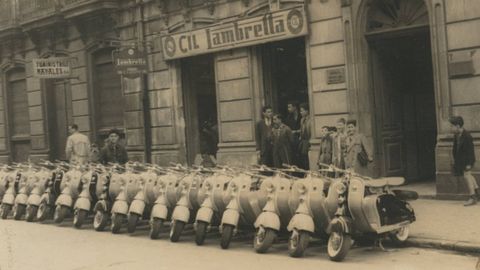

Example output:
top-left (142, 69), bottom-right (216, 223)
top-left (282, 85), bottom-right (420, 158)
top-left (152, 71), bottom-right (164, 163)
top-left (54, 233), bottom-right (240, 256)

top-left (100, 129), bottom-right (128, 164)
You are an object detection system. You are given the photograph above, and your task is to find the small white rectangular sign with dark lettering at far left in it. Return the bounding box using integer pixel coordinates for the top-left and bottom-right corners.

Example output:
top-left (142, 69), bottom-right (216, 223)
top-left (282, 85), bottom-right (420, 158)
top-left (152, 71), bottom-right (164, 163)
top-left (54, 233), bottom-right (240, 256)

top-left (32, 57), bottom-right (72, 79)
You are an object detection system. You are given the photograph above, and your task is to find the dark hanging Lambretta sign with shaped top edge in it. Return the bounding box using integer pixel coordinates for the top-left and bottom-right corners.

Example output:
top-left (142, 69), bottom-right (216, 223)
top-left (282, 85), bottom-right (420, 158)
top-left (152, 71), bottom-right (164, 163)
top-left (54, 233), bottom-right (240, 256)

top-left (113, 47), bottom-right (147, 77)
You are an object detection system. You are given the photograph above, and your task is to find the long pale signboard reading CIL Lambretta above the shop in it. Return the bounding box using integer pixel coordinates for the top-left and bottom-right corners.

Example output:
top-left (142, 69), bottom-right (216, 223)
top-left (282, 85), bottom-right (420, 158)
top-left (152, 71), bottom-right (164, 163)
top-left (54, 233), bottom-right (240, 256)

top-left (162, 6), bottom-right (308, 60)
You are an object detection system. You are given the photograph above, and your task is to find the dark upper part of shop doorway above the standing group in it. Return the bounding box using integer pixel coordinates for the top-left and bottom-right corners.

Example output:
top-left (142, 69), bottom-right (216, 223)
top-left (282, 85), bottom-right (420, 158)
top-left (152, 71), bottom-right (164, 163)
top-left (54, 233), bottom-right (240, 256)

top-left (260, 38), bottom-right (308, 117)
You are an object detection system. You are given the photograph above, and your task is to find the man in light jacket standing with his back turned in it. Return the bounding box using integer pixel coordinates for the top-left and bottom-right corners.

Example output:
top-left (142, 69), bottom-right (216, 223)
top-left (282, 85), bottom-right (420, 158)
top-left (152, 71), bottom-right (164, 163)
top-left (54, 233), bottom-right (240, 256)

top-left (65, 124), bottom-right (90, 164)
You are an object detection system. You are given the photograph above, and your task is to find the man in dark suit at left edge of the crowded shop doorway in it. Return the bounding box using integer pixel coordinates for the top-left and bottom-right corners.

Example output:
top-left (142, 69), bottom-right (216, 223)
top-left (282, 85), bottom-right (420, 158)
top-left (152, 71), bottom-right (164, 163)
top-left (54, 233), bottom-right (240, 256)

top-left (255, 105), bottom-right (273, 167)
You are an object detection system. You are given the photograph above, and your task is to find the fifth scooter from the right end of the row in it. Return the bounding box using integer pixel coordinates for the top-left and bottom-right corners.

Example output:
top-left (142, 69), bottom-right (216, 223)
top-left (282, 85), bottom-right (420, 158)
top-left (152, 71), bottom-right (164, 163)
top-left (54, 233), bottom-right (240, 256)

top-left (194, 168), bottom-right (233, 246)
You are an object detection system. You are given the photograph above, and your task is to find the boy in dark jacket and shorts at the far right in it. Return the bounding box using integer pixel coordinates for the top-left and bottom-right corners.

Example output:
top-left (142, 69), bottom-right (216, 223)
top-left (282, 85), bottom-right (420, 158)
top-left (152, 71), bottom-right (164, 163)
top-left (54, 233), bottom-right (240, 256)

top-left (450, 116), bottom-right (480, 206)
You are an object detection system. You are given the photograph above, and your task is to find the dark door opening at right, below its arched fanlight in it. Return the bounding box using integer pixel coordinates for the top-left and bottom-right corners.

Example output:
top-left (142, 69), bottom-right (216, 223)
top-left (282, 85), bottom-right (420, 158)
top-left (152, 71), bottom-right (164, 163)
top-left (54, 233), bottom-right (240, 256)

top-left (369, 27), bottom-right (437, 182)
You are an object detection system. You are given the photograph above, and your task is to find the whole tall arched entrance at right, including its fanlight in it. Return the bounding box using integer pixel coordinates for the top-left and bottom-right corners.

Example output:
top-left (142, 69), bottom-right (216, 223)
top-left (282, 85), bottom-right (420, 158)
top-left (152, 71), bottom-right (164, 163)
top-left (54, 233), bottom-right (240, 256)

top-left (364, 0), bottom-right (437, 182)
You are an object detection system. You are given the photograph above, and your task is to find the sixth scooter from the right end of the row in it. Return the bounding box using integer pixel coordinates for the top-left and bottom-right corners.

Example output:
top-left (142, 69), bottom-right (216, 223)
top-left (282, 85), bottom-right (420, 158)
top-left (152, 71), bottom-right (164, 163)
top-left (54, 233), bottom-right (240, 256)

top-left (170, 168), bottom-right (205, 242)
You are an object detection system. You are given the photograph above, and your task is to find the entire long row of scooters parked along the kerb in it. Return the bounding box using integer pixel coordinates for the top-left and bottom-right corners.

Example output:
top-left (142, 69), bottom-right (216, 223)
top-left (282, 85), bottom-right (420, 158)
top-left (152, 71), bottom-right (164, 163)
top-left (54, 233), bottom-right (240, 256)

top-left (0, 161), bottom-right (416, 261)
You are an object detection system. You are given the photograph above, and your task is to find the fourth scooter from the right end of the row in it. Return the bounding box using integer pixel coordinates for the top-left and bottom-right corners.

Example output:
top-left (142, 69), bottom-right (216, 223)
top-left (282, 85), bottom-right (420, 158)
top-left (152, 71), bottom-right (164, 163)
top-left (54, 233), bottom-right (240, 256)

top-left (219, 171), bottom-right (267, 249)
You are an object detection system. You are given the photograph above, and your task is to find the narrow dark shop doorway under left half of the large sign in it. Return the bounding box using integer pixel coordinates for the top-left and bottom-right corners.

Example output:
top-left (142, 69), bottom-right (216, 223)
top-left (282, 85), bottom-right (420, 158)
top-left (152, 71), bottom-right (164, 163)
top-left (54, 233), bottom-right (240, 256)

top-left (181, 55), bottom-right (218, 165)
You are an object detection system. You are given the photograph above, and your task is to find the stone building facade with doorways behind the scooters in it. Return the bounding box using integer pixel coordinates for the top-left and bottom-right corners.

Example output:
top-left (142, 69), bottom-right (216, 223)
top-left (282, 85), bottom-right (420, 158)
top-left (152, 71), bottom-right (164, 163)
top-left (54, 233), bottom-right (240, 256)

top-left (0, 0), bottom-right (480, 198)
